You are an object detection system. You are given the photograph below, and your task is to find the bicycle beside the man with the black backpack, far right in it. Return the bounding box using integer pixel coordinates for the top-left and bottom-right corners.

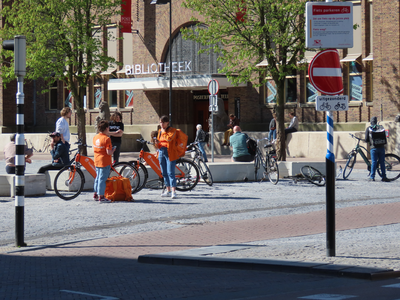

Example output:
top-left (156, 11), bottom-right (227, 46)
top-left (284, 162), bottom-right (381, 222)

top-left (343, 133), bottom-right (400, 181)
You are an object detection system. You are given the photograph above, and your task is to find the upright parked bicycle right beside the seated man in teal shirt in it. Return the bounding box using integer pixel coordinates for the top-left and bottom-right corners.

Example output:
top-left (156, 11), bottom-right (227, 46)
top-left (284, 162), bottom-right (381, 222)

top-left (254, 139), bottom-right (279, 184)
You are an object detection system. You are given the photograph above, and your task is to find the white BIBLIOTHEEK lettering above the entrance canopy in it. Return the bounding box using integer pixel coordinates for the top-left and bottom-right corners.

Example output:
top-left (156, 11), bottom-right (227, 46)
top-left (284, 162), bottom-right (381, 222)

top-left (125, 61), bottom-right (192, 75)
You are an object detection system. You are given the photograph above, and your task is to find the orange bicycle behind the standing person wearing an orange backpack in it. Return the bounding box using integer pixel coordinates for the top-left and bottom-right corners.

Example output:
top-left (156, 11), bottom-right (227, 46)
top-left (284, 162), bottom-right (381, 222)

top-left (130, 139), bottom-right (199, 192)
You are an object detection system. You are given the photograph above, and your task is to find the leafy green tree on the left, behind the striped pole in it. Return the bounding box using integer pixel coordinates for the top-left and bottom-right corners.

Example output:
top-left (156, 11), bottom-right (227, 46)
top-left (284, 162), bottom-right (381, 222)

top-left (0, 0), bottom-right (121, 154)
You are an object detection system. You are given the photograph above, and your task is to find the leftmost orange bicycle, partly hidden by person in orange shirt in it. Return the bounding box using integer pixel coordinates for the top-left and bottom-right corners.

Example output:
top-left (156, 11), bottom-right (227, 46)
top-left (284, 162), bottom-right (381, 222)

top-left (54, 140), bottom-right (140, 200)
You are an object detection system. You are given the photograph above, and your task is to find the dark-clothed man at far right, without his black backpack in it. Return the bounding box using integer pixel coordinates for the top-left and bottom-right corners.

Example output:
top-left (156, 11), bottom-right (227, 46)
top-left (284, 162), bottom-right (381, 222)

top-left (365, 117), bottom-right (390, 182)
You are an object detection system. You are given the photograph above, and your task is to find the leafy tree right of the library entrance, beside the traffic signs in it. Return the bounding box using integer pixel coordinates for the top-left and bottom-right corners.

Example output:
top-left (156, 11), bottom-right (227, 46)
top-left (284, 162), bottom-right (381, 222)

top-left (183, 0), bottom-right (305, 160)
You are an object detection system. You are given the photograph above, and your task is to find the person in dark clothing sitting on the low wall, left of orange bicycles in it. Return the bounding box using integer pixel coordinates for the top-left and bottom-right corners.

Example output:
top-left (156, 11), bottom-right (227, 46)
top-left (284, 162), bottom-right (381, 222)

top-left (38, 132), bottom-right (69, 173)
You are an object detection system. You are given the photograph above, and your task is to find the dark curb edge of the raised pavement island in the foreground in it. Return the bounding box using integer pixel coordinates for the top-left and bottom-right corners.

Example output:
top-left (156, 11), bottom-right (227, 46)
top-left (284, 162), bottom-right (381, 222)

top-left (138, 245), bottom-right (400, 280)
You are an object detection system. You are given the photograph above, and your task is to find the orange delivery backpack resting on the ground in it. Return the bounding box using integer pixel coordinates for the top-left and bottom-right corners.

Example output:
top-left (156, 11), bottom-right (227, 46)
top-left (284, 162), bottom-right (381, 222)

top-left (104, 176), bottom-right (133, 202)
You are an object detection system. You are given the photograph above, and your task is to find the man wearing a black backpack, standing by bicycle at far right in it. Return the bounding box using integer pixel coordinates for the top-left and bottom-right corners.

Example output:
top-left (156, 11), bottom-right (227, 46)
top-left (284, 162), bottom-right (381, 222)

top-left (365, 117), bottom-right (390, 182)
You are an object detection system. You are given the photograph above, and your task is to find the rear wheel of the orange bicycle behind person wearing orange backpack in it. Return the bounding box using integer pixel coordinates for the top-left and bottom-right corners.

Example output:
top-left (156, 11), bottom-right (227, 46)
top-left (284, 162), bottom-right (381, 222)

top-left (175, 158), bottom-right (200, 191)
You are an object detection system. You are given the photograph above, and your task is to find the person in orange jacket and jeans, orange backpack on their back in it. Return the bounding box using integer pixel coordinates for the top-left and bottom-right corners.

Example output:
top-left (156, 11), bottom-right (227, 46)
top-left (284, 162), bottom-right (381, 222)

top-left (154, 116), bottom-right (179, 199)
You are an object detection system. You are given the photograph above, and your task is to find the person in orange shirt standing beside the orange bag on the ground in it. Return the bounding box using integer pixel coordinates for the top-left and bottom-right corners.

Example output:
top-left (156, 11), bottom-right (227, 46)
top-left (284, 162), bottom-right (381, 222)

top-left (93, 120), bottom-right (115, 202)
